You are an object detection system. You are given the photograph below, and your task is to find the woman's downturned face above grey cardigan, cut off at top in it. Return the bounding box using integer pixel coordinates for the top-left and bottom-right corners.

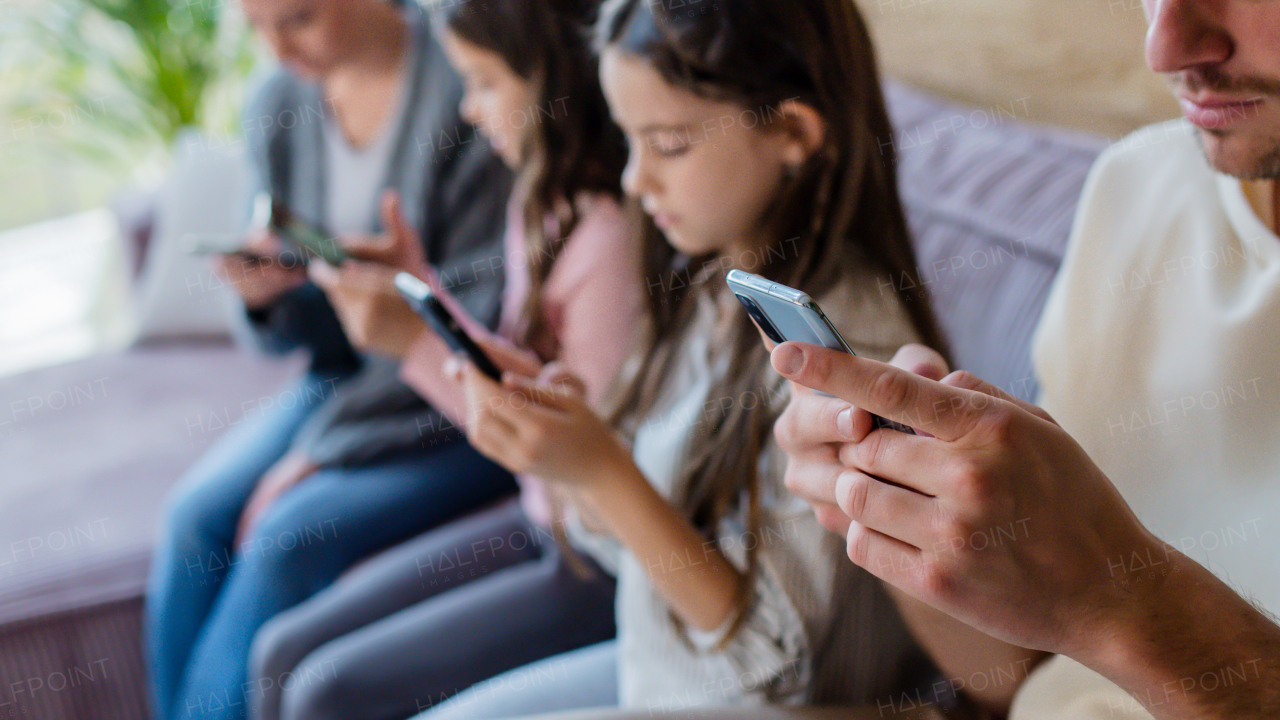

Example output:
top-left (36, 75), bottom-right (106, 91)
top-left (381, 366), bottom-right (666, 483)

top-left (241, 0), bottom-right (353, 79)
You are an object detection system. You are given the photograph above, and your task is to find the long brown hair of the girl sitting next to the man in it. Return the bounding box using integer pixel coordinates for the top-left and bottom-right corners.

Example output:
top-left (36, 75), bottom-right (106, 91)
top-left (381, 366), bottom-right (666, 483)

top-left (596, 0), bottom-right (946, 639)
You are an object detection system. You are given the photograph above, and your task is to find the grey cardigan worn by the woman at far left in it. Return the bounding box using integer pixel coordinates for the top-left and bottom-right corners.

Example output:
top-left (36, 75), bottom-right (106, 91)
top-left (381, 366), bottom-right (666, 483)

top-left (243, 3), bottom-right (512, 466)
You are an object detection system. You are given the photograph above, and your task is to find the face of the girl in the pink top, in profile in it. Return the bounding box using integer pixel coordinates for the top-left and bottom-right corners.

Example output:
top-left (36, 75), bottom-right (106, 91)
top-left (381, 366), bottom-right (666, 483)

top-left (440, 29), bottom-right (538, 169)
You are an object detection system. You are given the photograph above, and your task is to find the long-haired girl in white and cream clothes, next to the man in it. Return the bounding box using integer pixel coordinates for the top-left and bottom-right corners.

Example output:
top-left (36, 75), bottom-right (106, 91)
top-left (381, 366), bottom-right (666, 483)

top-left (424, 0), bottom-right (1039, 720)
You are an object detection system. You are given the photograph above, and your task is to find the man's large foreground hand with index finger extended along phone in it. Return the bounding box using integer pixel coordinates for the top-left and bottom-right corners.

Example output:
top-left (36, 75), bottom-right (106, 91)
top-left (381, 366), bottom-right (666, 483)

top-left (773, 343), bottom-right (1164, 653)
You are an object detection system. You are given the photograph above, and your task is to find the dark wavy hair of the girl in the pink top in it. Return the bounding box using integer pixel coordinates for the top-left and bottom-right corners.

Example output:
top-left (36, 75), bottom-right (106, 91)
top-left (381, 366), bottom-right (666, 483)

top-left (430, 0), bottom-right (626, 360)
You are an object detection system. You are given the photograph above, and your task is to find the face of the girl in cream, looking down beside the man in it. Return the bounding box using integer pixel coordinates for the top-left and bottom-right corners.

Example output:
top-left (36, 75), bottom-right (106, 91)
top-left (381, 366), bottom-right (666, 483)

top-left (600, 47), bottom-right (805, 260)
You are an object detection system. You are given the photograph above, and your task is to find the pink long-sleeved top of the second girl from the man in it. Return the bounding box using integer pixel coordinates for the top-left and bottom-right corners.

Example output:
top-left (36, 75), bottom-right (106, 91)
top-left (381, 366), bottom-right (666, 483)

top-left (401, 196), bottom-right (645, 525)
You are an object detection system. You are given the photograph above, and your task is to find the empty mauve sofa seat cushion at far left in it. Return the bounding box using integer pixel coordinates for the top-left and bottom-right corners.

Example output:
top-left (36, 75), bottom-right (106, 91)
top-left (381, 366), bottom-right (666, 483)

top-left (0, 345), bottom-right (301, 609)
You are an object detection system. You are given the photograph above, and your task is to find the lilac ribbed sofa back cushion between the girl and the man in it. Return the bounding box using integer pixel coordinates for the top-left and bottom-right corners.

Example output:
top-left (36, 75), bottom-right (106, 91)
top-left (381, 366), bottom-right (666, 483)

top-left (882, 82), bottom-right (1106, 400)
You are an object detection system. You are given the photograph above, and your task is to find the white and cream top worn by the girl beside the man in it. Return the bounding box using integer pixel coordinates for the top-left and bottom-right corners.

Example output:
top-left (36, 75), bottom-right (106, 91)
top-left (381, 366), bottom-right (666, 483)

top-left (571, 275), bottom-right (920, 711)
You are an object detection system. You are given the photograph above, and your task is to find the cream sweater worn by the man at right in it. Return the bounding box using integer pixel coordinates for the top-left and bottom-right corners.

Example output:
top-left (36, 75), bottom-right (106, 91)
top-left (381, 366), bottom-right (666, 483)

top-left (1012, 120), bottom-right (1280, 720)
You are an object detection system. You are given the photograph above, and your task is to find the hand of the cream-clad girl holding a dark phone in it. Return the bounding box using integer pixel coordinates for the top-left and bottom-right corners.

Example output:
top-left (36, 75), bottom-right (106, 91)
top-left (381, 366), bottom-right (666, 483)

top-left (462, 363), bottom-right (631, 488)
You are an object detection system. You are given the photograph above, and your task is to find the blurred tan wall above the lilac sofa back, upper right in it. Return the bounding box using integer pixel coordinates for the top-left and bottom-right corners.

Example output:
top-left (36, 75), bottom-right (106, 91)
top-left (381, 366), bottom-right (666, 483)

top-left (856, 0), bottom-right (1179, 140)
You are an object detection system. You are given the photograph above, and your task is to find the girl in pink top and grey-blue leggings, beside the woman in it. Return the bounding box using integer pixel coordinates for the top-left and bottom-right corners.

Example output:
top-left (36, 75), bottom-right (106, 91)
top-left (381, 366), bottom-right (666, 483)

top-left (253, 0), bottom-right (644, 720)
